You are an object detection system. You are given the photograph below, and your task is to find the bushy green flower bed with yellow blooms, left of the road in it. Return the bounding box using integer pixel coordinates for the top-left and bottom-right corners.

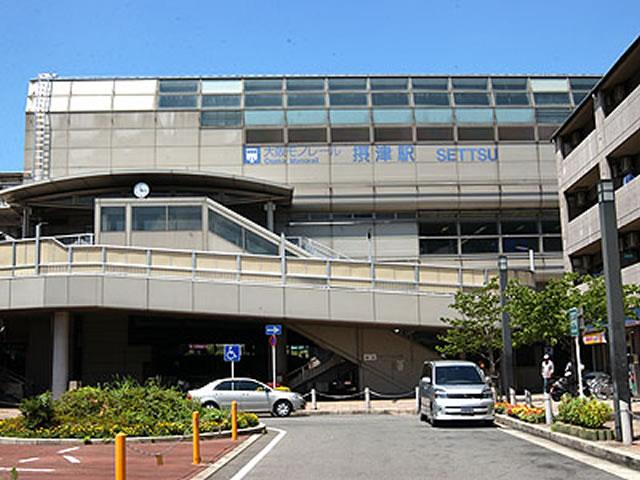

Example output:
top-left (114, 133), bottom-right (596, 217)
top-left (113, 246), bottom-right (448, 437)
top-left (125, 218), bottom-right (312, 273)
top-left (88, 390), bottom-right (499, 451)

top-left (0, 380), bottom-right (259, 439)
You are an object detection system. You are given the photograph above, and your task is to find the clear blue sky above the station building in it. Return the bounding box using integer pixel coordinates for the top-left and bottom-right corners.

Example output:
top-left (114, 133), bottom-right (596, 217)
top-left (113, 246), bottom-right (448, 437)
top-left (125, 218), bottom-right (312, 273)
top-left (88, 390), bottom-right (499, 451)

top-left (0, 0), bottom-right (640, 171)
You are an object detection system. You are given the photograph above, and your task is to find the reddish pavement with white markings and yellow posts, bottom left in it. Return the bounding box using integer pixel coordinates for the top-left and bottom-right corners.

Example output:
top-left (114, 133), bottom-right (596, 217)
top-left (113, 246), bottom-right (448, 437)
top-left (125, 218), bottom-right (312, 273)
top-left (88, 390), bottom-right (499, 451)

top-left (0, 437), bottom-right (246, 480)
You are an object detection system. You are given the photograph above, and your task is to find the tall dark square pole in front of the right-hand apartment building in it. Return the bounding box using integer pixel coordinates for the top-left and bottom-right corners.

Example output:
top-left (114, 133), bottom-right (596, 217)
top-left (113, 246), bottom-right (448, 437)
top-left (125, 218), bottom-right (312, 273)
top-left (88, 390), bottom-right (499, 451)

top-left (598, 180), bottom-right (633, 444)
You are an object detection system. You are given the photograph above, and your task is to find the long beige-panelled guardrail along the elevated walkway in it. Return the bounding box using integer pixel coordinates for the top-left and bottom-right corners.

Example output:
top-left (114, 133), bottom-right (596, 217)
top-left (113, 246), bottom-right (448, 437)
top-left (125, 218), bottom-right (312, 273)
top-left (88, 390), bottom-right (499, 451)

top-left (0, 237), bottom-right (531, 293)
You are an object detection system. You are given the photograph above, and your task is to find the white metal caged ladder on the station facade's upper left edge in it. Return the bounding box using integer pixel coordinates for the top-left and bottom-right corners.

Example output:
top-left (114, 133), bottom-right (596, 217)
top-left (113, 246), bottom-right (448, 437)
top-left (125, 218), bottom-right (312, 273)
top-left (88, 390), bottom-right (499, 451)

top-left (33, 73), bottom-right (56, 180)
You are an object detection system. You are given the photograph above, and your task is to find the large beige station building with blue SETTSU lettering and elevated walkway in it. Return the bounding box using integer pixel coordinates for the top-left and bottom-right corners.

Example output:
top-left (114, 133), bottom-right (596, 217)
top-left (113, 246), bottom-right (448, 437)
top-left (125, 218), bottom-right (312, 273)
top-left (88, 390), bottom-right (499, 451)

top-left (0, 74), bottom-right (598, 402)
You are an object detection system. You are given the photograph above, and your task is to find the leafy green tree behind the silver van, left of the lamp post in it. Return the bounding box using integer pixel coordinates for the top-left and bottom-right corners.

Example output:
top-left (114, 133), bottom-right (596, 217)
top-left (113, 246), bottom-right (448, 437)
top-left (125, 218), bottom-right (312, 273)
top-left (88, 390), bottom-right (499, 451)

top-left (436, 278), bottom-right (502, 376)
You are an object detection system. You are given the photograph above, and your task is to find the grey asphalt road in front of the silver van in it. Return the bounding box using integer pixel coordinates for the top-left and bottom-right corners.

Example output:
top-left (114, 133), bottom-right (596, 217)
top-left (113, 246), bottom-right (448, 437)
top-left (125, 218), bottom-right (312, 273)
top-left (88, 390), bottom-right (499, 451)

top-left (212, 415), bottom-right (640, 480)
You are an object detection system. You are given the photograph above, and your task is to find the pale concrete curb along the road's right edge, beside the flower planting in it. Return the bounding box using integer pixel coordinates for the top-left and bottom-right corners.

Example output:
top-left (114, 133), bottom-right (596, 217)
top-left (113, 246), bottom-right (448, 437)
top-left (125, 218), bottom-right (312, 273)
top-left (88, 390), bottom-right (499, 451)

top-left (496, 414), bottom-right (640, 471)
